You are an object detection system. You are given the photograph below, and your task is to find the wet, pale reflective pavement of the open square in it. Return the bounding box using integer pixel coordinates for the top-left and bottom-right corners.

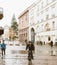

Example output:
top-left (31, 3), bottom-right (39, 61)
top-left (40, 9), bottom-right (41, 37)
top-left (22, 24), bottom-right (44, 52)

top-left (0, 45), bottom-right (57, 65)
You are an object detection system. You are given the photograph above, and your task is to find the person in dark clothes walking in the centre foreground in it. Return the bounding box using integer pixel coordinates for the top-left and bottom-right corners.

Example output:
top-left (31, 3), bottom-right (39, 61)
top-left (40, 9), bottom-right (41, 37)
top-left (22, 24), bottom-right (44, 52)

top-left (26, 41), bottom-right (35, 60)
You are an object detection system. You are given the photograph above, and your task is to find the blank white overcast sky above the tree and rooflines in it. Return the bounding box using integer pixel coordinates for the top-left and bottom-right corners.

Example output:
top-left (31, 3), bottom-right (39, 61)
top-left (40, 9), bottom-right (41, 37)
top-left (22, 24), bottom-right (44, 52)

top-left (0, 0), bottom-right (36, 27)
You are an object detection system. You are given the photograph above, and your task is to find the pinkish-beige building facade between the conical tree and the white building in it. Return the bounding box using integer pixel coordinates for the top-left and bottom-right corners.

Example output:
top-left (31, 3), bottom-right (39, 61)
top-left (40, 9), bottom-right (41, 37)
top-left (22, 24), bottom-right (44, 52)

top-left (18, 9), bottom-right (29, 42)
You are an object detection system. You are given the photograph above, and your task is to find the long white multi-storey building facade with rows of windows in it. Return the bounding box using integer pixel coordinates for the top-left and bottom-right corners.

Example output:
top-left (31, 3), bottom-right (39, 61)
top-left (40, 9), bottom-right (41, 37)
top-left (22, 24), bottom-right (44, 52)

top-left (29, 0), bottom-right (57, 44)
